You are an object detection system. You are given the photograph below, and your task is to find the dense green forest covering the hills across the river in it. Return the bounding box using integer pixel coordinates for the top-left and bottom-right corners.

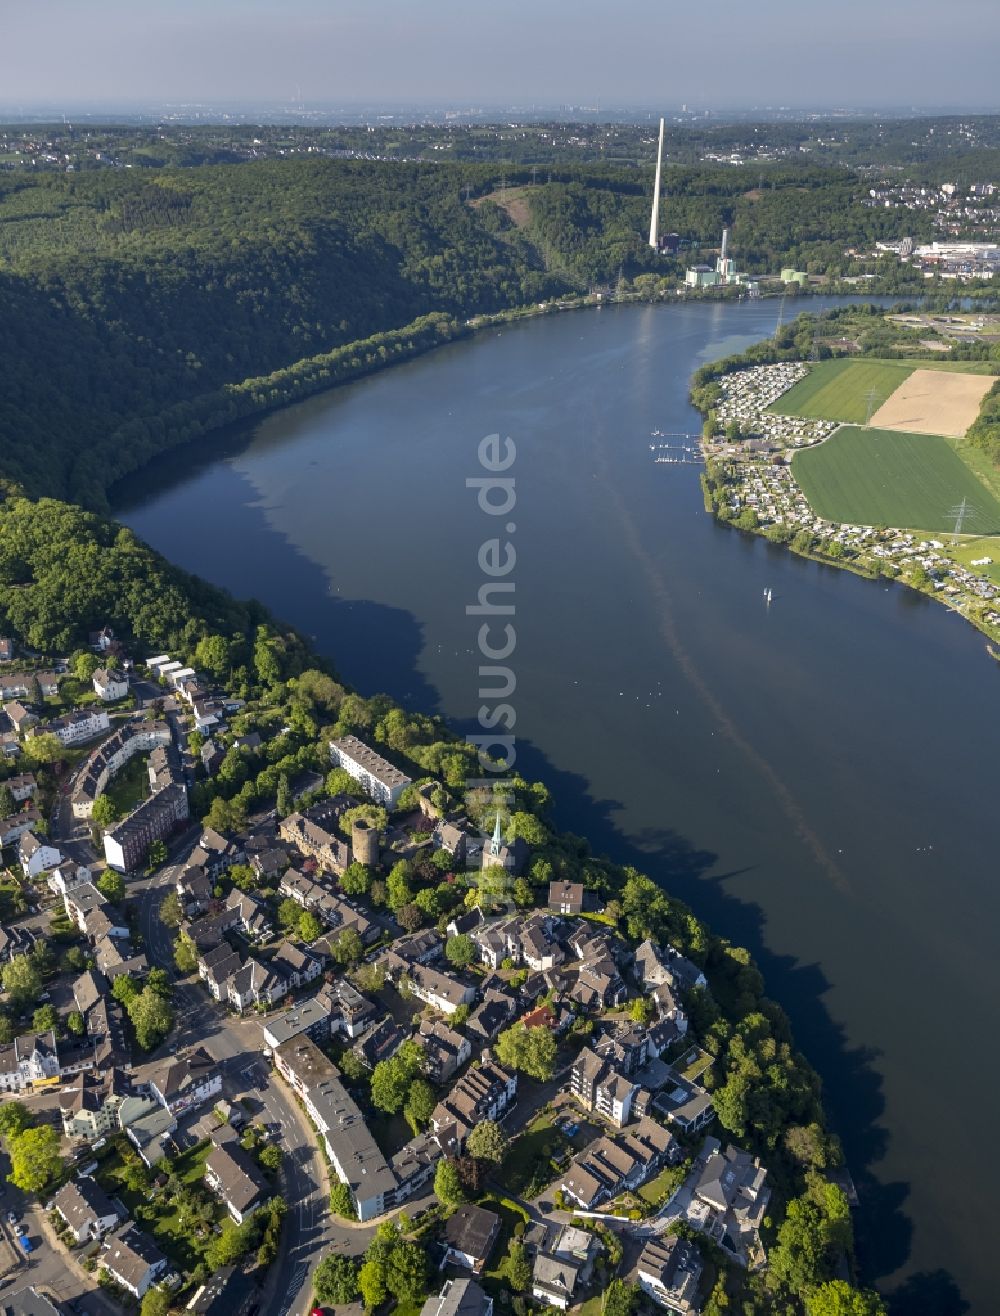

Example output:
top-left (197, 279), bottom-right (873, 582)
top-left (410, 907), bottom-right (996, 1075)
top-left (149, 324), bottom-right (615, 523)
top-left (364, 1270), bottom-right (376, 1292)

top-left (0, 159), bottom-right (931, 508)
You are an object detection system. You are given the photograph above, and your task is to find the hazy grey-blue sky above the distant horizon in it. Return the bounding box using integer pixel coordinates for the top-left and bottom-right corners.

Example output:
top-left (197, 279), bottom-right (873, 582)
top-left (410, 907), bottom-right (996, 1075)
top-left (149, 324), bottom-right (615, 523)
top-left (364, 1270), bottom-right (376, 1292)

top-left (7, 0), bottom-right (1000, 108)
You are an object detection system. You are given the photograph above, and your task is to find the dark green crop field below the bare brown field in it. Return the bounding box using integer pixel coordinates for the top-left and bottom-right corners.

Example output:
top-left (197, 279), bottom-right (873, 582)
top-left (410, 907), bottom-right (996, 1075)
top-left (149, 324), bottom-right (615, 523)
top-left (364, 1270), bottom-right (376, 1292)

top-left (792, 425), bottom-right (1000, 534)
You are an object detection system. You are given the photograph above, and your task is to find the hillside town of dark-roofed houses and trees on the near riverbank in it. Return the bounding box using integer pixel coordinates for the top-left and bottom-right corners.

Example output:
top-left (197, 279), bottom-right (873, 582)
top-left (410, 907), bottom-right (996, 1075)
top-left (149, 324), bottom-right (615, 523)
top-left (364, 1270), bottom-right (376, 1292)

top-left (0, 628), bottom-right (850, 1316)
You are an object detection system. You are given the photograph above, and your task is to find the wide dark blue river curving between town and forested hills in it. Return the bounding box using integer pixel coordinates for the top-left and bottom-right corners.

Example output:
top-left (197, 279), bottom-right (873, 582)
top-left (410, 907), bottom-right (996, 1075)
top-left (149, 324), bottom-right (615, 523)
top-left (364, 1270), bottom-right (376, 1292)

top-left (118, 303), bottom-right (1000, 1316)
